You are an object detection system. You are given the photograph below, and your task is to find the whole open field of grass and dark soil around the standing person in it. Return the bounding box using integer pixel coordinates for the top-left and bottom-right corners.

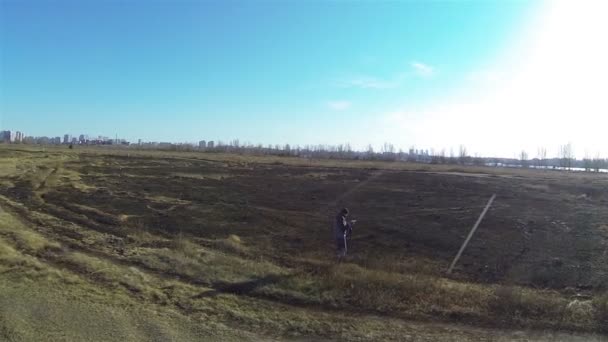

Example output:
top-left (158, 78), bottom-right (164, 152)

top-left (0, 146), bottom-right (608, 341)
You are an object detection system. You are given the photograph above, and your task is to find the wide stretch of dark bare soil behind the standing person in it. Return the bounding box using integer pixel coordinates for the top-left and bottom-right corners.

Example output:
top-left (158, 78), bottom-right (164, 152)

top-left (1, 155), bottom-right (608, 290)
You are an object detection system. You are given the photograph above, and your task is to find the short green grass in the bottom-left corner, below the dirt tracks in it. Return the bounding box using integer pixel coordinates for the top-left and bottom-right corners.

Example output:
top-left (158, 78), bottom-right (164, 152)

top-left (0, 272), bottom-right (252, 342)
